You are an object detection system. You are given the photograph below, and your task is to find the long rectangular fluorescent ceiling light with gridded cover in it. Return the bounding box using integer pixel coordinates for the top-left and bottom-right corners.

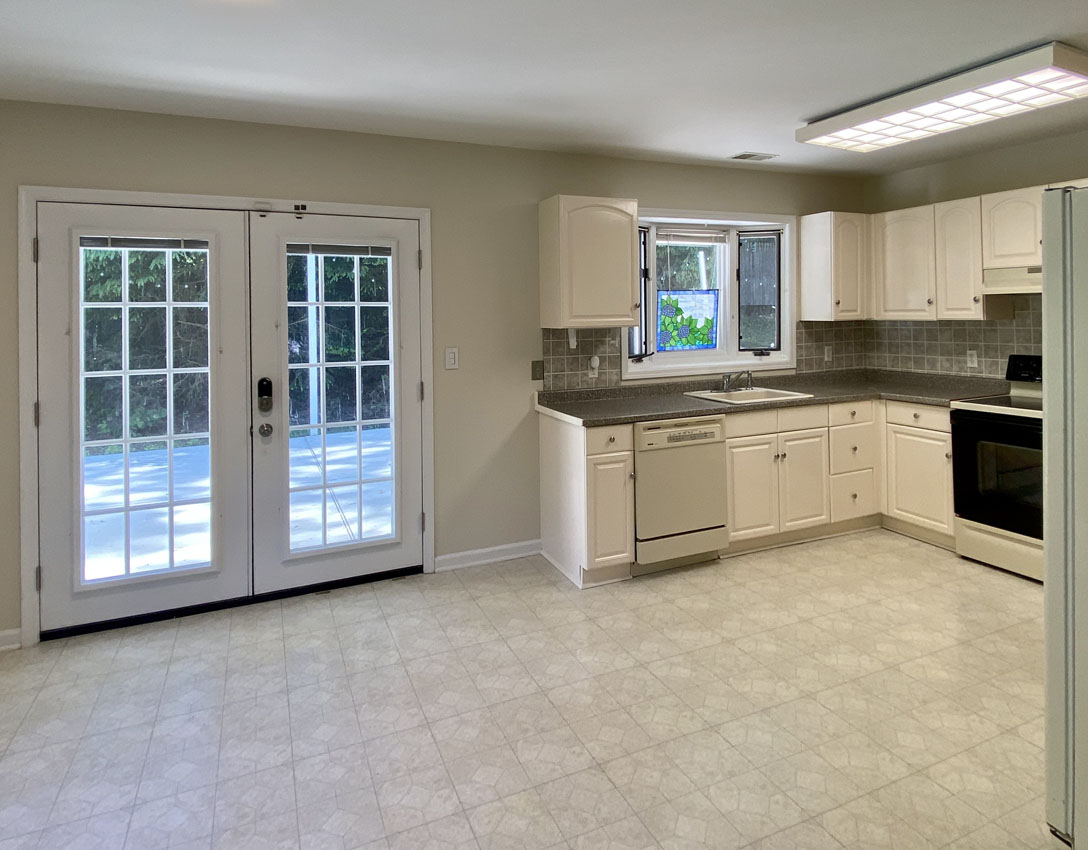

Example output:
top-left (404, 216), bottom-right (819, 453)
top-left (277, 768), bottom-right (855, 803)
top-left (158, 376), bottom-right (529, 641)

top-left (796, 41), bottom-right (1088, 152)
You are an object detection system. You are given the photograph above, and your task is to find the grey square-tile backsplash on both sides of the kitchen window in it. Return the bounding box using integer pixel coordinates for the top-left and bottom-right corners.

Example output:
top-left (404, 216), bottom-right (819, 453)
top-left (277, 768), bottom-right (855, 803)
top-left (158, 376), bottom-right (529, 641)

top-left (544, 295), bottom-right (1042, 391)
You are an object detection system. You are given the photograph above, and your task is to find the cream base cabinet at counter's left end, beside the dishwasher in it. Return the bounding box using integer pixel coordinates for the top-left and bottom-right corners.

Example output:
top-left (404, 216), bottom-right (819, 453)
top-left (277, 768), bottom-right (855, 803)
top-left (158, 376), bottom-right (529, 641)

top-left (540, 416), bottom-right (634, 588)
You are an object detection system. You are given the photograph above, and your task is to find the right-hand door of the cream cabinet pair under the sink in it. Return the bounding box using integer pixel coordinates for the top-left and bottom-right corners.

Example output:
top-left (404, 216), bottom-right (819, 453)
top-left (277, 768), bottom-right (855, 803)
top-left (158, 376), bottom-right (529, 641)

top-left (778, 428), bottom-right (831, 531)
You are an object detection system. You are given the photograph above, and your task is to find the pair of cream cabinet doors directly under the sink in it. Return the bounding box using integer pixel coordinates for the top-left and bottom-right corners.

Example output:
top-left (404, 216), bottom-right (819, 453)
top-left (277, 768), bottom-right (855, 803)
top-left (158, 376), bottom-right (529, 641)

top-left (726, 428), bottom-right (831, 541)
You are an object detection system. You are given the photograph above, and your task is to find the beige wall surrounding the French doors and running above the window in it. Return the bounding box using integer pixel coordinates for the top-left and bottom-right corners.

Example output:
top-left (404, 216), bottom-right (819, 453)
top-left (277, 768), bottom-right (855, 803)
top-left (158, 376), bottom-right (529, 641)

top-left (0, 101), bottom-right (862, 630)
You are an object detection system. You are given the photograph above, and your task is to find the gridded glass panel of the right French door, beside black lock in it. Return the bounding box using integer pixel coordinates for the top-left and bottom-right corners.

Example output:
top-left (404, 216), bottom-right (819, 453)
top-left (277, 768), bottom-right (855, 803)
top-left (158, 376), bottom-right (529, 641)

top-left (284, 245), bottom-right (396, 552)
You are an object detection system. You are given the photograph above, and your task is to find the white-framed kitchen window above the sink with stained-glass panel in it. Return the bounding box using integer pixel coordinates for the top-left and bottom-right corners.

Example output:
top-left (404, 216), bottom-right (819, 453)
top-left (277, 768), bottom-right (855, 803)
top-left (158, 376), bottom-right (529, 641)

top-left (623, 208), bottom-right (795, 379)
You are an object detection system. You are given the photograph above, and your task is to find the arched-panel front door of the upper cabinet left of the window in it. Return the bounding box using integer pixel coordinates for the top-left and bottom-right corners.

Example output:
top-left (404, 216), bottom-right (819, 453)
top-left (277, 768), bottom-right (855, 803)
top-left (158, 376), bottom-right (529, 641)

top-left (559, 196), bottom-right (639, 328)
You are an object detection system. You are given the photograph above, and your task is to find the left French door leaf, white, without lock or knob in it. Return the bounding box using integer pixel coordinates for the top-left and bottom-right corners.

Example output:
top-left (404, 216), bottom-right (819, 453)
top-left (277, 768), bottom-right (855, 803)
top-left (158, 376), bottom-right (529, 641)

top-left (38, 204), bottom-right (249, 631)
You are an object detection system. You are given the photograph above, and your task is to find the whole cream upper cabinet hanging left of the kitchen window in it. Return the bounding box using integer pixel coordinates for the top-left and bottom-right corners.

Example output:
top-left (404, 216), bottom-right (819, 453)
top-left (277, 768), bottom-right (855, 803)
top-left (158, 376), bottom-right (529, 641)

top-left (540, 195), bottom-right (640, 328)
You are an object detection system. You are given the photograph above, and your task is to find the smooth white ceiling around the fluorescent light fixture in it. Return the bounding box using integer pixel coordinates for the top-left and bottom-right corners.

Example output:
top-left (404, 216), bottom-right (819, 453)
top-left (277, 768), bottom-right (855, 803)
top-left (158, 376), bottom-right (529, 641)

top-left (0, 0), bottom-right (1088, 173)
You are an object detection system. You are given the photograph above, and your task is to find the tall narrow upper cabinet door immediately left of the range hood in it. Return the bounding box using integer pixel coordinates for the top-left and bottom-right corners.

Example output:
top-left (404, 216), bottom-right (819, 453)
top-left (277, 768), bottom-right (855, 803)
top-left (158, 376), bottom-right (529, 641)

top-left (934, 198), bottom-right (982, 319)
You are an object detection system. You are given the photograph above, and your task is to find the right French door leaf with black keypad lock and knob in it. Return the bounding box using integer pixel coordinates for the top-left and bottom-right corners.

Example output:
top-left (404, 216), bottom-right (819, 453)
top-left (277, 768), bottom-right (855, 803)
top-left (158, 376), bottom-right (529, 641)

top-left (250, 212), bottom-right (423, 593)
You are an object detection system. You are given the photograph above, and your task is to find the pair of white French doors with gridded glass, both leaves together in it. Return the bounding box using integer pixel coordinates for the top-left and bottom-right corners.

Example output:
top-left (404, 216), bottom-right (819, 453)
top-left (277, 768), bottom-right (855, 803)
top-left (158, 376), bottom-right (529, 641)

top-left (37, 201), bottom-right (422, 631)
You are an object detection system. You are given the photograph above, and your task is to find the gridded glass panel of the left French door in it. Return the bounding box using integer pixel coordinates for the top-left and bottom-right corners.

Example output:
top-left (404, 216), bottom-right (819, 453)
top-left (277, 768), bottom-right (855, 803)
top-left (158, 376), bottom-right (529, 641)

top-left (79, 236), bottom-right (211, 583)
